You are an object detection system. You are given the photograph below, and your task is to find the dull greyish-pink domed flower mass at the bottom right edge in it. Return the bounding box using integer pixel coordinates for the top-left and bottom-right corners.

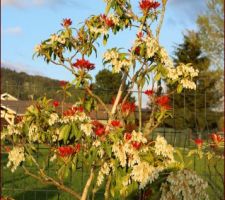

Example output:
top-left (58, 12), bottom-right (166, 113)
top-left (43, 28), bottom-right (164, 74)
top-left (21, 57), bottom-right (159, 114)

top-left (160, 169), bottom-right (209, 200)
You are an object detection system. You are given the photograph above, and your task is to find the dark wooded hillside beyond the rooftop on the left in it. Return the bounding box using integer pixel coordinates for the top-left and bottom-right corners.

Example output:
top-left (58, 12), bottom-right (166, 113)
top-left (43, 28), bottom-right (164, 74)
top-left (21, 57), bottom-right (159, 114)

top-left (1, 67), bottom-right (81, 102)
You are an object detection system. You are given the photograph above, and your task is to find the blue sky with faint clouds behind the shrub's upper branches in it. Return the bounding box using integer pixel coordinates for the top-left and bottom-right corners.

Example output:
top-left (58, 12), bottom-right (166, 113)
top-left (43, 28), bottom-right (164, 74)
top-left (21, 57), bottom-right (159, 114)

top-left (1, 0), bottom-right (206, 80)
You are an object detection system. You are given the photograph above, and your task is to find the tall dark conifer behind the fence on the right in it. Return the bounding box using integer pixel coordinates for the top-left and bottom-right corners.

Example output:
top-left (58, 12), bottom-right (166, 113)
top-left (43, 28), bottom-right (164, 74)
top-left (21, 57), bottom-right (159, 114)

top-left (165, 31), bottom-right (222, 130)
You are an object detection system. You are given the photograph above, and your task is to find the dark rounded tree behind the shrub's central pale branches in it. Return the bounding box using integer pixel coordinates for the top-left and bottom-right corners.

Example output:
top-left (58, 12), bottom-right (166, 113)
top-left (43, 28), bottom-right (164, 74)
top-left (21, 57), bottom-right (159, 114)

top-left (94, 69), bottom-right (134, 104)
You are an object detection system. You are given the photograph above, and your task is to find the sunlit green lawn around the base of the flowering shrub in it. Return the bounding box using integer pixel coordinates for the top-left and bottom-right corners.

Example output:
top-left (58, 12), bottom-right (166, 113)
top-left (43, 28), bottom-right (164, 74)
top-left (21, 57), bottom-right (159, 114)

top-left (1, 143), bottom-right (224, 200)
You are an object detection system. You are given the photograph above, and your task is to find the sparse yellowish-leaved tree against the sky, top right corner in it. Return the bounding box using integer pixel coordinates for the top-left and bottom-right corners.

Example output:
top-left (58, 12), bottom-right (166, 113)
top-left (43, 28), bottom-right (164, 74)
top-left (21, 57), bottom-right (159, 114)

top-left (197, 0), bottom-right (224, 68)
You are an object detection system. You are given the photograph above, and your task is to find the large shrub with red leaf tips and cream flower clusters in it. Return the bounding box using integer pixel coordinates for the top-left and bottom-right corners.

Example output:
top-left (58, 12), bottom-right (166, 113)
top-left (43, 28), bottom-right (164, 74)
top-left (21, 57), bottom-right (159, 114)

top-left (2, 0), bottom-right (207, 200)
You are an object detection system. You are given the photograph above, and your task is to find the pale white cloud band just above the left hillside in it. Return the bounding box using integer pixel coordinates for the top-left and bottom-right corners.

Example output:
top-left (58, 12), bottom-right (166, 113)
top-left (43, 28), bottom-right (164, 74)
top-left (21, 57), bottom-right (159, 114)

top-left (1, 61), bottom-right (45, 76)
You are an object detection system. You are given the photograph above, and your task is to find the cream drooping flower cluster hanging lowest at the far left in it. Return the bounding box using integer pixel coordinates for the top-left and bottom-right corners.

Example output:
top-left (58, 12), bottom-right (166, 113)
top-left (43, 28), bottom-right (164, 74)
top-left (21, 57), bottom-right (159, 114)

top-left (7, 146), bottom-right (25, 172)
